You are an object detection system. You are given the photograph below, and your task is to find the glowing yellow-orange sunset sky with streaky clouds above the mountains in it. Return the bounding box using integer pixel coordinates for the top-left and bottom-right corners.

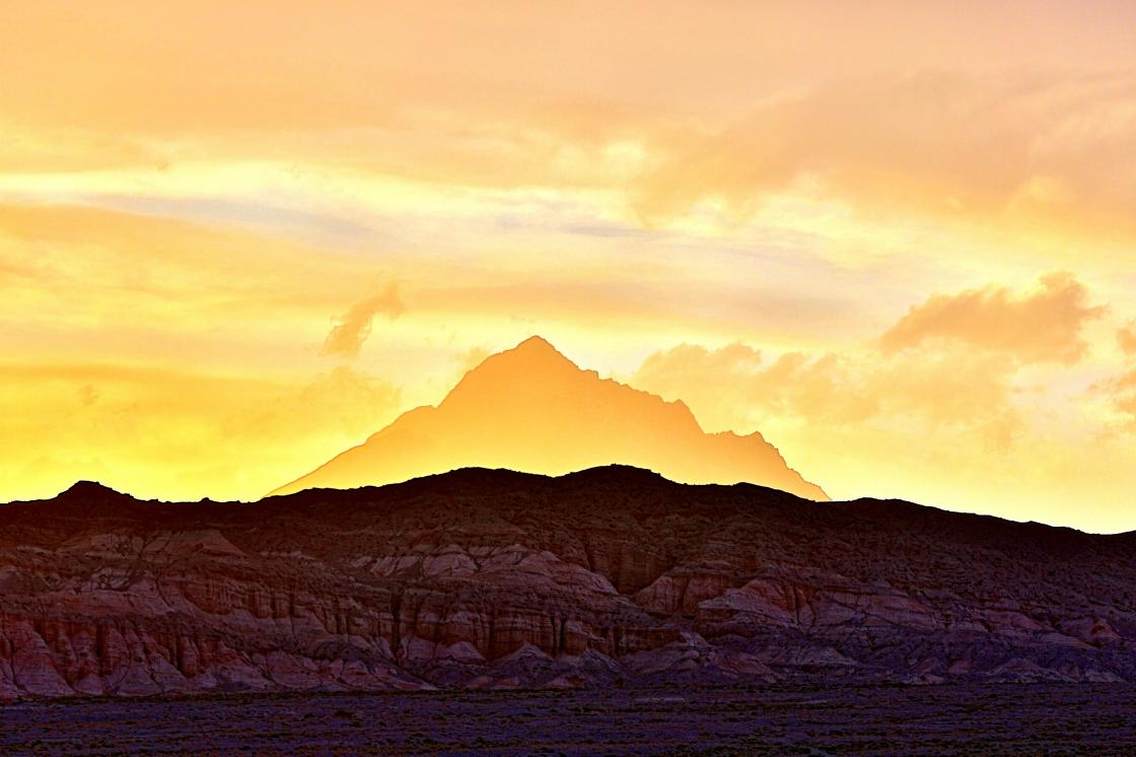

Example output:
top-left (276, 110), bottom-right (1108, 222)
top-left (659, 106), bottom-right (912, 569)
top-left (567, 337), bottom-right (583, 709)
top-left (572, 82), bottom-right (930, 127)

top-left (0, 0), bottom-right (1136, 531)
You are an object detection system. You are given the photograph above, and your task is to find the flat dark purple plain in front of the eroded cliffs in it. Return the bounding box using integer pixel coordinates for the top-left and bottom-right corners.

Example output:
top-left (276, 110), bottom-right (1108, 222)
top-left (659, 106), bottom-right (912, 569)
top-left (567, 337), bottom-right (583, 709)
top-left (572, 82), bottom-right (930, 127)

top-left (0, 684), bottom-right (1136, 755)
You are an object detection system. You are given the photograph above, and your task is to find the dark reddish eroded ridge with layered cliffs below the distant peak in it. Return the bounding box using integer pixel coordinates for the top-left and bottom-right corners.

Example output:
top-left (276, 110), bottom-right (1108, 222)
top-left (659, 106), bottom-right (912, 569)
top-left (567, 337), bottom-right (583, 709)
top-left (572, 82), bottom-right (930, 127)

top-left (0, 467), bottom-right (1136, 699)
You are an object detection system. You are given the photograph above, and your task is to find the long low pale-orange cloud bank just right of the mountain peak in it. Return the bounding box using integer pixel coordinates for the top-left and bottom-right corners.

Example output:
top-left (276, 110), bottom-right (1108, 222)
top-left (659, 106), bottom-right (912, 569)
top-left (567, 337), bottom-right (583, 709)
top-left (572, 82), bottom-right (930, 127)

top-left (630, 336), bottom-right (1019, 446)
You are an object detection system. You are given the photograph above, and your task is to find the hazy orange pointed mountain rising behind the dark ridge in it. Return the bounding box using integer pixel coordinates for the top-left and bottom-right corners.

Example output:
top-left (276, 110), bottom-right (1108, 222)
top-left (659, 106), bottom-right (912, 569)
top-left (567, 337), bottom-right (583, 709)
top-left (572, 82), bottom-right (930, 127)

top-left (273, 336), bottom-right (827, 500)
